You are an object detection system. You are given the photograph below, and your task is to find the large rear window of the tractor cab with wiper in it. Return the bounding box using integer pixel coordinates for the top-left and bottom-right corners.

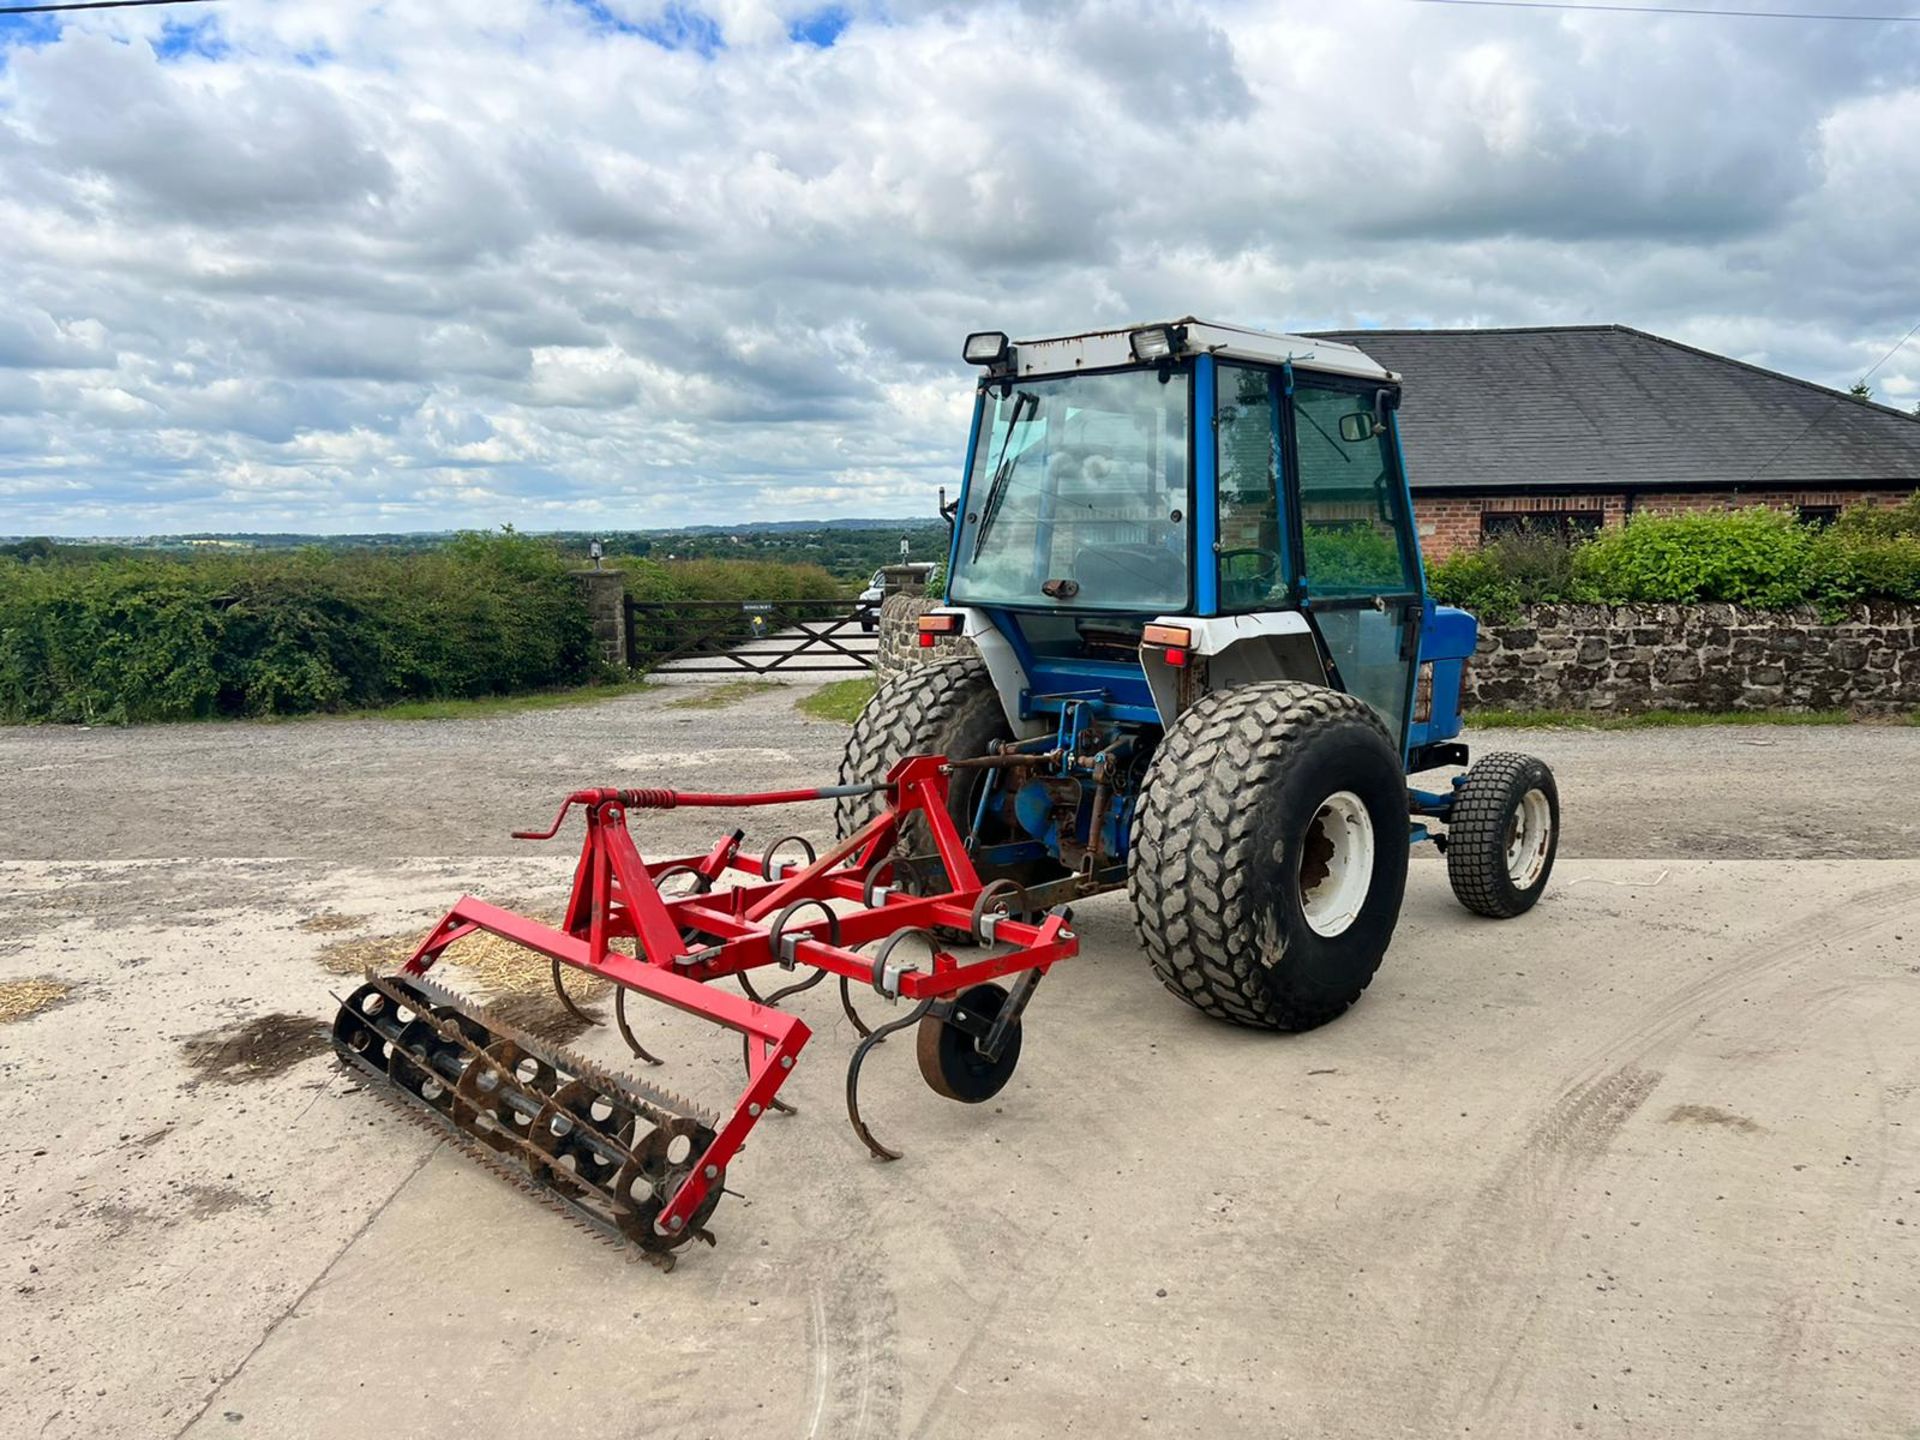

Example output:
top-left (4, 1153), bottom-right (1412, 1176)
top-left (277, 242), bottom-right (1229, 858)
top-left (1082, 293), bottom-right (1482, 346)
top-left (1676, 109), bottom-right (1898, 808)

top-left (950, 371), bottom-right (1190, 612)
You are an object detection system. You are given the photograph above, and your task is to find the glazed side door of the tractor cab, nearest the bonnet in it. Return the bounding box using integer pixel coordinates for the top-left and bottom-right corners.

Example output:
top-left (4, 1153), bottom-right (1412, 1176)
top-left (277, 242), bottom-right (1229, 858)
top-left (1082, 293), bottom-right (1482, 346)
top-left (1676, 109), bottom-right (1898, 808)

top-left (1286, 376), bottom-right (1423, 749)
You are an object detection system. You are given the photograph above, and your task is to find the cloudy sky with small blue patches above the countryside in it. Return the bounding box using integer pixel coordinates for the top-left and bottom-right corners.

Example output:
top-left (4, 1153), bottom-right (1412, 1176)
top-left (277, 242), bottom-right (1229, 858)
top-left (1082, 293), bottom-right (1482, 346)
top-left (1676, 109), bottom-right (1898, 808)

top-left (0, 0), bottom-right (1920, 534)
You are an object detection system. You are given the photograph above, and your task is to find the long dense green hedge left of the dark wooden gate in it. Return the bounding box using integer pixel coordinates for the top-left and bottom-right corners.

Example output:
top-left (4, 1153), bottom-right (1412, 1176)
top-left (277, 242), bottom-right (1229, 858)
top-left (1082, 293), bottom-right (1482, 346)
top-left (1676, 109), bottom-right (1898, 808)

top-left (0, 532), bottom-right (595, 722)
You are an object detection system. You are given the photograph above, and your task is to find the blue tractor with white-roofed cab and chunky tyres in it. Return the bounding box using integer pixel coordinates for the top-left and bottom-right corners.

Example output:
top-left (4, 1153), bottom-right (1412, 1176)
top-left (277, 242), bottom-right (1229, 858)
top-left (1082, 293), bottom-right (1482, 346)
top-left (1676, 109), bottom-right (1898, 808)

top-left (839, 319), bottom-right (1559, 1029)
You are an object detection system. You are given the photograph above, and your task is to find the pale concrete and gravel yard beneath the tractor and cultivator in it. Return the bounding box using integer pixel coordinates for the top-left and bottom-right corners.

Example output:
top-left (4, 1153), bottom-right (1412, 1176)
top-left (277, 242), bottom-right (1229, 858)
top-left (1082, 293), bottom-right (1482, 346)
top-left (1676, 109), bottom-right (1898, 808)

top-left (0, 693), bottom-right (1920, 1440)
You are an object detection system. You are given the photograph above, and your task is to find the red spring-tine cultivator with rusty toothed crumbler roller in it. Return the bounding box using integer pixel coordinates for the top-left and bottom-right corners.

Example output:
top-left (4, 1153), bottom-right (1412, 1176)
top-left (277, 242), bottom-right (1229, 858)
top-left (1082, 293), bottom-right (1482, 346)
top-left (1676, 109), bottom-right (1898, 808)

top-left (334, 756), bottom-right (1077, 1265)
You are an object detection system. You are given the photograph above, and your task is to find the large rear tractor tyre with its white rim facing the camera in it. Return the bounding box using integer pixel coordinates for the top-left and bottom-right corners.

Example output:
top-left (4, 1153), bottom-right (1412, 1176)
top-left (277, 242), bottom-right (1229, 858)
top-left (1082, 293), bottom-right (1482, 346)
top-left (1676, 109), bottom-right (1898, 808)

top-left (1127, 682), bottom-right (1407, 1031)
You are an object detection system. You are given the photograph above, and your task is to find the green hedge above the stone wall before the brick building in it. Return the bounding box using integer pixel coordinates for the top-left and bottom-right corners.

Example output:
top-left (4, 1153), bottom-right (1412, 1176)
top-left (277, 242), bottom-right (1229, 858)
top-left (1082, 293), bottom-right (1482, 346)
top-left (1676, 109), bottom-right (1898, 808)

top-left (1428, 493), bottom-right (1920, 620)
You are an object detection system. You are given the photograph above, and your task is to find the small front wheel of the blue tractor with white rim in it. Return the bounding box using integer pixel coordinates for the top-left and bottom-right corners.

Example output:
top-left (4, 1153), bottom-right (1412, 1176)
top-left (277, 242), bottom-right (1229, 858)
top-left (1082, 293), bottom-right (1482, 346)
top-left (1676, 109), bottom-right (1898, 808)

top-left (1446, 751), bottom-right (1559, 920)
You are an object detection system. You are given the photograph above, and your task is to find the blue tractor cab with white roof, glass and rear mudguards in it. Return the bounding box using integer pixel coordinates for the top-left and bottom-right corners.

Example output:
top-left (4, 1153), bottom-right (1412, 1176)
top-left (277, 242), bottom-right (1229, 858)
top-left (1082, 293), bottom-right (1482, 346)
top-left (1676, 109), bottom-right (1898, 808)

top-left (929, 319), bottom-right (1475, 758)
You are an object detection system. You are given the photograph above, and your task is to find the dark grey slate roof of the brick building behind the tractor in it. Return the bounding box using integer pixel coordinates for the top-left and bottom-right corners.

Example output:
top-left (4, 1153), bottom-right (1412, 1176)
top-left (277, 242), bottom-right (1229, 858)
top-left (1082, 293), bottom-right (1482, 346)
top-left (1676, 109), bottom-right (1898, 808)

top-left (1325, 324), bottom-right (1920, 492)
